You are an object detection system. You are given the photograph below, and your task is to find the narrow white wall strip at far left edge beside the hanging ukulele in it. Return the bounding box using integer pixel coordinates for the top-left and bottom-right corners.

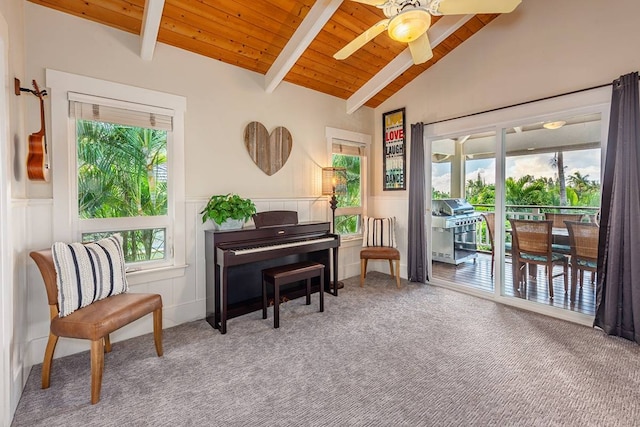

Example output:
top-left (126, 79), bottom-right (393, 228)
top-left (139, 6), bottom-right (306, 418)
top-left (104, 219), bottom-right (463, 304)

top-left (0, 0), bottom-right (29, 426)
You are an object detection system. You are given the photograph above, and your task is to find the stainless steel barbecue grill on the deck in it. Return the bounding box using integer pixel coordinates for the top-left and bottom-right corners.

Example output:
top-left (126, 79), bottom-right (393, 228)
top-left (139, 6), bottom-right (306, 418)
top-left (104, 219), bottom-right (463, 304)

top-left (431, 199), bottom-right (482, 265)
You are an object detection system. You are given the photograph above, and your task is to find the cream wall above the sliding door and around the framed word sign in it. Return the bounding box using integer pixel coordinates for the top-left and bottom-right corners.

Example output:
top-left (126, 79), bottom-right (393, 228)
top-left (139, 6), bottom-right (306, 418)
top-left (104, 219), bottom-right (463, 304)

top-left (372, 0), bottom-right (640, 268)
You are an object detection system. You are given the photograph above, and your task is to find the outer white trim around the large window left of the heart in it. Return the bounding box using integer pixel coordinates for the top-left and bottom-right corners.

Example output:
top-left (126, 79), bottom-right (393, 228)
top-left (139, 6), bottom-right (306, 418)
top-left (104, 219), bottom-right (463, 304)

top-left (46, 69), bottom-right (187, 277)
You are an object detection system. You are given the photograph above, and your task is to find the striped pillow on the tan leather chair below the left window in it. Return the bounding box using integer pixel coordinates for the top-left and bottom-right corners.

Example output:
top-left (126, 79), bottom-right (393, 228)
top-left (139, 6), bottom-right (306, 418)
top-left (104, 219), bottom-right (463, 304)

top-left (51, 234), bottom-right (129, 317)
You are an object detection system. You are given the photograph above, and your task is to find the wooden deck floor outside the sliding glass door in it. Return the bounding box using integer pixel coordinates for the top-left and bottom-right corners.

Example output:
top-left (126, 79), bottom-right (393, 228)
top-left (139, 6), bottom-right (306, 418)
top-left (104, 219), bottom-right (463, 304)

top-left (433, 253), bottom-right (596, 316)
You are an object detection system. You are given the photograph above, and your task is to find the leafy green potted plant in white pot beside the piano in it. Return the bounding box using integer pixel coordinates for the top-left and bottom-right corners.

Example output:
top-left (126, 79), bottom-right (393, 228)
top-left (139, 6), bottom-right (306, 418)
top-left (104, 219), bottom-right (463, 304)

top-left (200, 194), bottom-right (256, 230)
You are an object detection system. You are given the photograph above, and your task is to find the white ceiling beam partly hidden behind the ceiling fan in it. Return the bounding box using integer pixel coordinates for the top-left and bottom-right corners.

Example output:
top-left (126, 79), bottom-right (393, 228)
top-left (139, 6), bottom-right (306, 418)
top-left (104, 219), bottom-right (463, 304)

top-left (347, 15), bottom-right (474, 114)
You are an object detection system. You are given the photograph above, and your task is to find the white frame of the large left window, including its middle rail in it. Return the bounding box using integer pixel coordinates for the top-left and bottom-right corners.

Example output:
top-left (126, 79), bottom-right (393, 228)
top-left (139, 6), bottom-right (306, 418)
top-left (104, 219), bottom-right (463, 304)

top-left (46, 69), bottom-right (186, 277)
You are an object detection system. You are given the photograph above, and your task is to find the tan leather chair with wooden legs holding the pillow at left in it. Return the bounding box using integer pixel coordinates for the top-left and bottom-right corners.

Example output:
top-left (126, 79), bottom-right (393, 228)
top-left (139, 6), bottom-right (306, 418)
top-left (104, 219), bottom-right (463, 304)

top-left (29, 249), bottom-right (162, 404)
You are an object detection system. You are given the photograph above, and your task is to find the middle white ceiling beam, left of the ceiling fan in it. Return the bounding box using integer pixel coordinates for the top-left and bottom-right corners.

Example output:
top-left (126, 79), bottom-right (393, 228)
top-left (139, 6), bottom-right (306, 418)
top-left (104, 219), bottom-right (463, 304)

top-left (264, 0), bottom-right (343, 93)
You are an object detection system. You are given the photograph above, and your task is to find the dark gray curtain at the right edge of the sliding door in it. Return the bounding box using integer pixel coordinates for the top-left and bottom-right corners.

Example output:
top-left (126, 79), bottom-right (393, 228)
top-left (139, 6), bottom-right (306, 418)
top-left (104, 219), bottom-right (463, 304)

top-left (594, 72), bottom-right (640, 344)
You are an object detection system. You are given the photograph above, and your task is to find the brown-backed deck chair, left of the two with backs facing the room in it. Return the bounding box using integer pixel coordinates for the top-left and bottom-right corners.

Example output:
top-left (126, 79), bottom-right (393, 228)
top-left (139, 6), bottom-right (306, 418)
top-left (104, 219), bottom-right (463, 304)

top-left (509, 219), bottom-right (569, 298)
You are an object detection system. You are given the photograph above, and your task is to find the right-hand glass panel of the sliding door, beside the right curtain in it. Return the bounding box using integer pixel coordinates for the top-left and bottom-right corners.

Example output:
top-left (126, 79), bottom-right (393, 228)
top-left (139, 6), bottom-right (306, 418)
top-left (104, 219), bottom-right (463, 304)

top-left (502, 113), bottom-right (602, 315)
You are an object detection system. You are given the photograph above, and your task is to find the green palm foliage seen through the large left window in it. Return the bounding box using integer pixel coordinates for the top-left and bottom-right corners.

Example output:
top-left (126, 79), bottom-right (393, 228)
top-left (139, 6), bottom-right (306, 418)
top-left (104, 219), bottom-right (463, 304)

top-left (76, 120), bottom-right (168, 262)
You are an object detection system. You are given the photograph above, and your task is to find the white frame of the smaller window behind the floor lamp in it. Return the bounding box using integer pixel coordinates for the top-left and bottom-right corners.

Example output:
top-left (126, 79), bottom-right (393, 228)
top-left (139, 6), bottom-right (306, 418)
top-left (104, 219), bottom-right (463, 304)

top-left (325, 127), bottom-right (371, 241)
